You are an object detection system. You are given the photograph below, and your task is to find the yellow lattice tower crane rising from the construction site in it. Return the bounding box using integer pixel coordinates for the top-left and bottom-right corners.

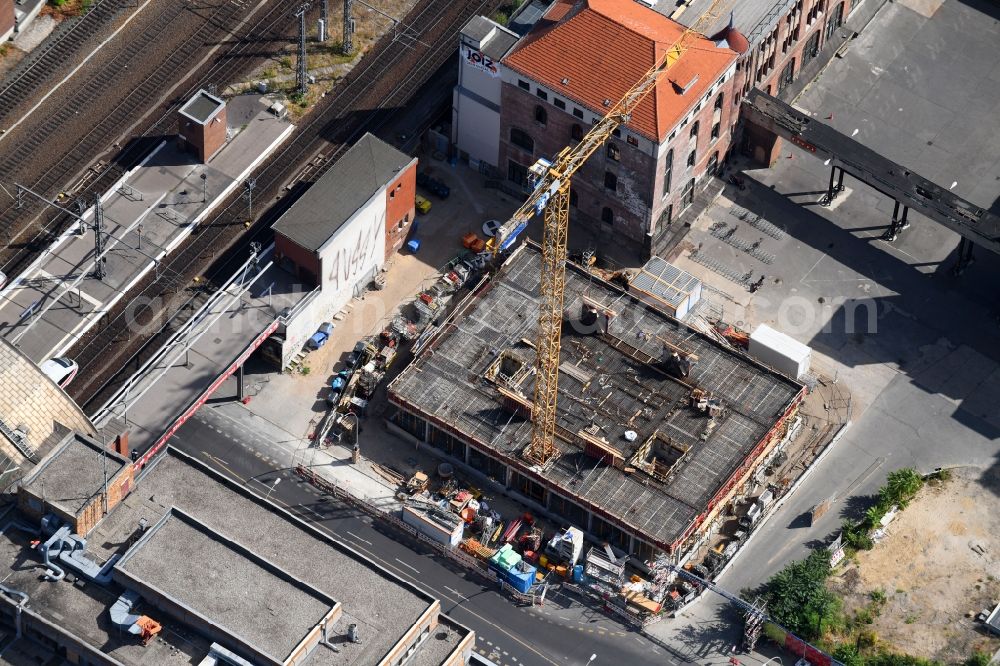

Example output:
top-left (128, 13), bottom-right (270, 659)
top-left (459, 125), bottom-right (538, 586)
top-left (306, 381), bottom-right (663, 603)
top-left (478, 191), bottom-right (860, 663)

top-left (487, 0), bottom-right (723, 465)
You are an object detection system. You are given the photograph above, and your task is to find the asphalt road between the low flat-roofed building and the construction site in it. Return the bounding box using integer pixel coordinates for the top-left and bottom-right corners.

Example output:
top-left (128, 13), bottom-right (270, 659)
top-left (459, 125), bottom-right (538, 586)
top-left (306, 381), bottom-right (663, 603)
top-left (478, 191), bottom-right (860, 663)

top-left (171, 415), bottom-right (683, 666)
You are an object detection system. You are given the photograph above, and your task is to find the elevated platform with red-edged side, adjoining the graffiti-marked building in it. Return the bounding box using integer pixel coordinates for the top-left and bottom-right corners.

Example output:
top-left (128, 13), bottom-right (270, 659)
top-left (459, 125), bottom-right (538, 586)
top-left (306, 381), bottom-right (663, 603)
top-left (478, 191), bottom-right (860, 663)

top-left (93, 246), bottom-right (313, 453)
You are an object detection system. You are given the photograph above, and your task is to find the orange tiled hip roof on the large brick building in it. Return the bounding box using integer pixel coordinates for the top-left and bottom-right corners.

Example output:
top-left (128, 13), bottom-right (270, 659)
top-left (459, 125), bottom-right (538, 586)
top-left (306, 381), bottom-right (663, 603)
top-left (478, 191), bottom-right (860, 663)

top-left (502, 0), bottom-right (737, 141)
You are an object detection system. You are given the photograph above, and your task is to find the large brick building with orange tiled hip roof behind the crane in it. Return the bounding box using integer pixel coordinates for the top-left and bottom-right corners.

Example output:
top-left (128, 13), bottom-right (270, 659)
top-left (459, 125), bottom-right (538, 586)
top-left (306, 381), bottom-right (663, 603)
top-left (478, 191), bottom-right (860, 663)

top-left (499, 0), bottom-right (746, 256)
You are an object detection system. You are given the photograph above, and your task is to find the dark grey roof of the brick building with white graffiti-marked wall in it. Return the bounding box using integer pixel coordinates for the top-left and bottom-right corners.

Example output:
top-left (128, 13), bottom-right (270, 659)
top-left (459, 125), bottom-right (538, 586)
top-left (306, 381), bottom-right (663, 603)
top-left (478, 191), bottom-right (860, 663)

top-left (271, 133), bottom-right (413, 252)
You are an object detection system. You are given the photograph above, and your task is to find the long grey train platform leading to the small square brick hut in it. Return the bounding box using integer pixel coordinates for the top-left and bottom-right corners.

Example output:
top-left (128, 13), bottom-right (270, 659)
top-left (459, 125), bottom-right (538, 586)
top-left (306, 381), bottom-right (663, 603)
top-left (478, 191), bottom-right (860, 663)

top-left (0, 102), bottom-right (294, 363)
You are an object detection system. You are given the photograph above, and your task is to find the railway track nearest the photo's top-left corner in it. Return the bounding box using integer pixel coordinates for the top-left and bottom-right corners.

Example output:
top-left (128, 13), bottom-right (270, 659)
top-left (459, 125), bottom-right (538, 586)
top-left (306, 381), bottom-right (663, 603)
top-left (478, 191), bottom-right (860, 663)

top-left (0, 0), bottom-right (133, 126)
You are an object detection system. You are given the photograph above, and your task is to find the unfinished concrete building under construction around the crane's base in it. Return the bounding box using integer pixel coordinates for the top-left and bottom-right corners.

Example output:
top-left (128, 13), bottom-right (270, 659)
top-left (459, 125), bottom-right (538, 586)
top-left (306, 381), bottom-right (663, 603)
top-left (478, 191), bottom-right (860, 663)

top-left (389, 243), bottom-right (805, 559)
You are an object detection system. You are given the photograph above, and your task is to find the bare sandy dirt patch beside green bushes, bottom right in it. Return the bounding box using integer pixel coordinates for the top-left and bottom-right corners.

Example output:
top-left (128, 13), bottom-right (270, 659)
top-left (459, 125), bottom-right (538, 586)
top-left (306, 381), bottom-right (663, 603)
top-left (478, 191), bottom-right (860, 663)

top-left (835, 467), bottom-right (1000, 664)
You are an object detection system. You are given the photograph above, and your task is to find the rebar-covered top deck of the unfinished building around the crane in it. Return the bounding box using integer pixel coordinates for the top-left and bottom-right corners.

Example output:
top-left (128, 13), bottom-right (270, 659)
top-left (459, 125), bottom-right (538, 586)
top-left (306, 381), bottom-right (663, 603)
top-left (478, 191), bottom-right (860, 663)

top-left (390, 243), bottom-right (803, 547)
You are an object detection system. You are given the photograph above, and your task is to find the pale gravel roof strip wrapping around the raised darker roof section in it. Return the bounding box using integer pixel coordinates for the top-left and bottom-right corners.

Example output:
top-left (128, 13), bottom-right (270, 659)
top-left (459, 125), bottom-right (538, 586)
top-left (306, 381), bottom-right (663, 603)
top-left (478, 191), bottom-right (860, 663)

top-left (94, 447), bottom-right (454, 666)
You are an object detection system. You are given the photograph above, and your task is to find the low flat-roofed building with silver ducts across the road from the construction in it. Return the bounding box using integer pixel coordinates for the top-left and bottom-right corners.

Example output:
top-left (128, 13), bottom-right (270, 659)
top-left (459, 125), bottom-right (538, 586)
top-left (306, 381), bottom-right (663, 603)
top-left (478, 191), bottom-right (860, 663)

top-left (0, 440), bottom-right (474, 666)
